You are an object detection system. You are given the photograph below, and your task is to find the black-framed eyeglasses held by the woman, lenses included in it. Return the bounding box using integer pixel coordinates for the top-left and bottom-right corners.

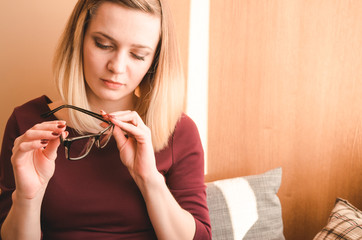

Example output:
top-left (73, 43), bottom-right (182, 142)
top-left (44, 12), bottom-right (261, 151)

top-left (41, 104), bottom-right (114, 161)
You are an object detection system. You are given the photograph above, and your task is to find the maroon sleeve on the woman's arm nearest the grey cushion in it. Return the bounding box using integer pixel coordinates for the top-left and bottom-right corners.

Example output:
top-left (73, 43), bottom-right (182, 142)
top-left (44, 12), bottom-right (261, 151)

top-left (166, 115), bottom-right (211, 239)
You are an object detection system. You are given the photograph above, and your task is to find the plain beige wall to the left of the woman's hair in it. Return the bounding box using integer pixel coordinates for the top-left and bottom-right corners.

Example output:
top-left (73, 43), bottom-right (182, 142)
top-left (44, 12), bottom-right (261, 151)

top-left (0, 0), bottom-right (76, 145)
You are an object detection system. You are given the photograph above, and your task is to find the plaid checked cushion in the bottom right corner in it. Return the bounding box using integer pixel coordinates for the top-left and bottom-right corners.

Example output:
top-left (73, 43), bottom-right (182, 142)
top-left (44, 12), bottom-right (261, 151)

top-left (314, 198), bottom-right (362, 240)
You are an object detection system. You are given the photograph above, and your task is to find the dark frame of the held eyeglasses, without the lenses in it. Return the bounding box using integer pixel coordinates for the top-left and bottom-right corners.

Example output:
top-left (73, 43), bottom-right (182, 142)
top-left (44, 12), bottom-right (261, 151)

top-left (40, 104), bottom-right (114, 161)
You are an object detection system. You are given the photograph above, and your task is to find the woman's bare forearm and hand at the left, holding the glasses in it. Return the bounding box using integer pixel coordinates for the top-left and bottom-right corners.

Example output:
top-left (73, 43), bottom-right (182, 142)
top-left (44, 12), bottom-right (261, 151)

top-left (1, 121), bottom-right (66, 240)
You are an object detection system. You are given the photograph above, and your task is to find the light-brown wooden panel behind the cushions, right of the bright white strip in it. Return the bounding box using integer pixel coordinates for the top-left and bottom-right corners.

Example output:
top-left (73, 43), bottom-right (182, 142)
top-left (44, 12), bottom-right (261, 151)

top-left (206, 0), bottom-right (362, 240)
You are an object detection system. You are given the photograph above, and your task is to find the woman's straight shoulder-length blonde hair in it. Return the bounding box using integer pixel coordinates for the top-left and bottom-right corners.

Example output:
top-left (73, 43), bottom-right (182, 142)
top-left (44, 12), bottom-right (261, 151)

top-left (54, 0), bottom-right (185, 151)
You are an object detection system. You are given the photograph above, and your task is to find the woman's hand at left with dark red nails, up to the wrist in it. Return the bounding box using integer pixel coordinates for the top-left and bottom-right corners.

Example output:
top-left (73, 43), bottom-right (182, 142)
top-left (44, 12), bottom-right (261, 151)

top-left (11, 121), bottom-right (67, 199)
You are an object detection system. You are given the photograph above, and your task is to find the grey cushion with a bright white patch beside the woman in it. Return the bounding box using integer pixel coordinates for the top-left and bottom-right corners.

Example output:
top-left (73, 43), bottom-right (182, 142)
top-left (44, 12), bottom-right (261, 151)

top-left (206, 168), bottom-right (285, 240)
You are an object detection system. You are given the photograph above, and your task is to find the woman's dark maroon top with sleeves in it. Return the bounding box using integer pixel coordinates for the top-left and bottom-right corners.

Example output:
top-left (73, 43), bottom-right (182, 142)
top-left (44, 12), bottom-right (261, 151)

top-left (0, 96), bottom-right (211, 240)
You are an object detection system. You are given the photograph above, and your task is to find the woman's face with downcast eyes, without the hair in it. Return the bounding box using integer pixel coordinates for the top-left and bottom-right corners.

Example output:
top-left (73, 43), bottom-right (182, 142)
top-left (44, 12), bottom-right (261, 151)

top-left (83, 2), bottom-right (161, 109)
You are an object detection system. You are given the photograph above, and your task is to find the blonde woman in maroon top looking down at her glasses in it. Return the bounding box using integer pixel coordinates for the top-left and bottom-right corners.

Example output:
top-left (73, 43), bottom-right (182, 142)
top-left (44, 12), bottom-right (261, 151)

top-left (0, 0), bottom-right (211, 239)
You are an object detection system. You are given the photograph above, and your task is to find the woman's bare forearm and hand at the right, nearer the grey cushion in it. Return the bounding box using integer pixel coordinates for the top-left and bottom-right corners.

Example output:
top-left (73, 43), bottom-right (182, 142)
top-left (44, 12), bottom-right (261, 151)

top-left (104, 111), bottom-right (201, 240)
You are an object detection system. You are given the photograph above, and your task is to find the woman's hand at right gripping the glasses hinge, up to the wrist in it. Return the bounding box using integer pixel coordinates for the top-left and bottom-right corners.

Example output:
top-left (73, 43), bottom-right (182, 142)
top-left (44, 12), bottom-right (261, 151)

top-left (102, 111), bottom-right (157, 179)
